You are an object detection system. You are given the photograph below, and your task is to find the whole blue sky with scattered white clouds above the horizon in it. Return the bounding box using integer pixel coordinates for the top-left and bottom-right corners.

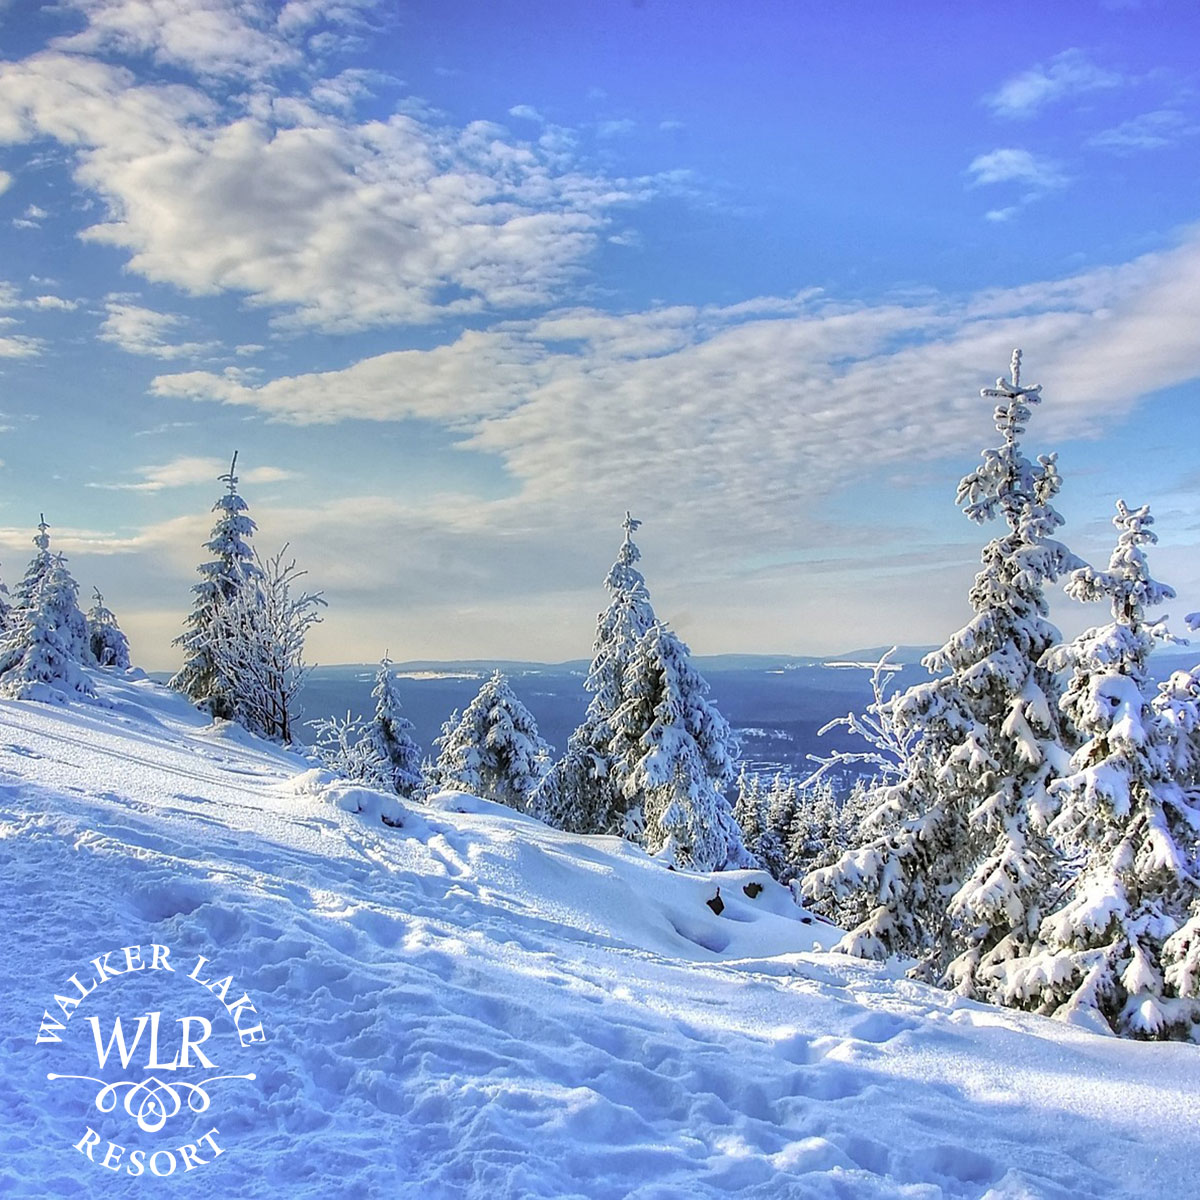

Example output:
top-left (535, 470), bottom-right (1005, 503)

top-left (0, 0), bottom-right (1200, 667)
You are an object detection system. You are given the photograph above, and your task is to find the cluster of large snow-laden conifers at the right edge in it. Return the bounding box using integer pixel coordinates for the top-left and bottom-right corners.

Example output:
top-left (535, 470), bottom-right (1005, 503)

top-left (803, 352), bottom-right (1200, 1037)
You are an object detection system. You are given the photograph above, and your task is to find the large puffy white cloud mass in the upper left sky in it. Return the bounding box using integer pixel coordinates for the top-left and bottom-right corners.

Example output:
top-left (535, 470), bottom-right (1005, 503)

top-left (0, 53), bottom-right (656, 329)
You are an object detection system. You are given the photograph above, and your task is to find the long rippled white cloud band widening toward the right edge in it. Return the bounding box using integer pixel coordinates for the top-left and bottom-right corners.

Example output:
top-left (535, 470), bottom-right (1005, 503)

top-left (152, 225), bottom-right (1200, 556)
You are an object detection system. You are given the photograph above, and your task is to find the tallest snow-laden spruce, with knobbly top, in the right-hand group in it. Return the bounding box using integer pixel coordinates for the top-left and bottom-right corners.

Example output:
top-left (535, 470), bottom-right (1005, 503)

top-left (804, 350), bottom-right (1082, 996)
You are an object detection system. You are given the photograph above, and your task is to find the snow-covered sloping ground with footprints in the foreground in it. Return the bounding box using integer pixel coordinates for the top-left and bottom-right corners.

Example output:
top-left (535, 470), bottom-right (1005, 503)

top-left (0, 680), bottom-right (1200, 1200)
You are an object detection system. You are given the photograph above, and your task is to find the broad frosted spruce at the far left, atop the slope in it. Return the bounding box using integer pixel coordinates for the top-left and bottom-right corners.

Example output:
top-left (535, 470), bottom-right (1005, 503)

top-left (0, 547), bottom-right (95, 703)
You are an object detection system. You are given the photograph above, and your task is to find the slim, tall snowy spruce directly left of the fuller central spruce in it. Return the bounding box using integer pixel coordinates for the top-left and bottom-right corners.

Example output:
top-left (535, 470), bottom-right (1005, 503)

top-left (530, 512), bottom-right (655, 833)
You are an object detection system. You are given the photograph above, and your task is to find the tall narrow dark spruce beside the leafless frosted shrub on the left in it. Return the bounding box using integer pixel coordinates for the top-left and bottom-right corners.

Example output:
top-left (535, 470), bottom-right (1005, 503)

top-left (169, 451), bottom-right (260, 719)
